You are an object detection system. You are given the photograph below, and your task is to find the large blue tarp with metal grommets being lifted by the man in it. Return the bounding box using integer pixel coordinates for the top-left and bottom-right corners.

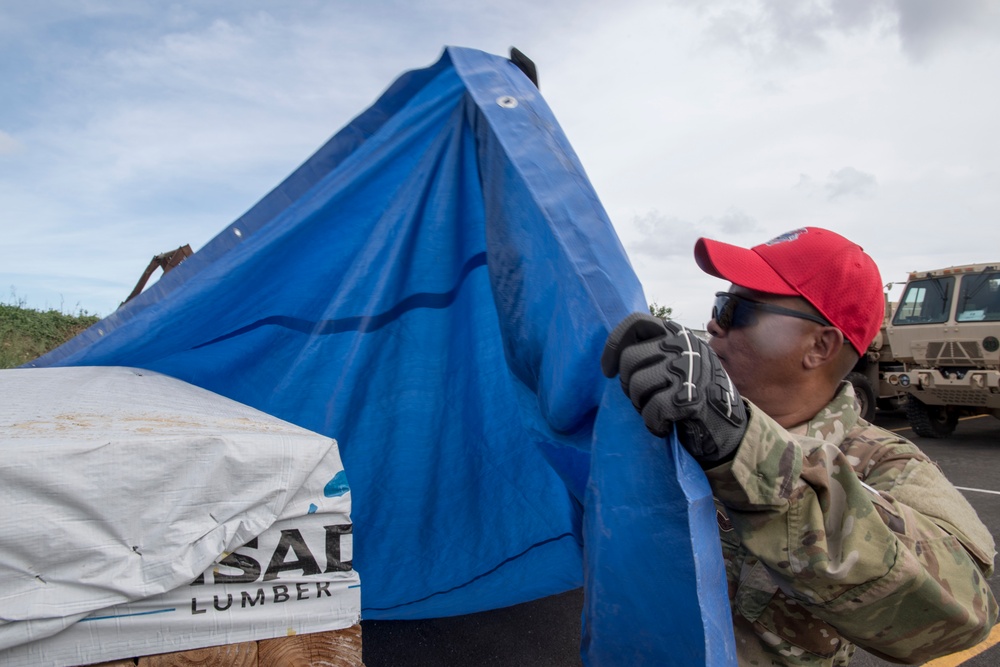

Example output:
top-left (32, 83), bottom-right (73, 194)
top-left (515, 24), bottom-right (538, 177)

top-left (32, 48), bottom-right (735, 665)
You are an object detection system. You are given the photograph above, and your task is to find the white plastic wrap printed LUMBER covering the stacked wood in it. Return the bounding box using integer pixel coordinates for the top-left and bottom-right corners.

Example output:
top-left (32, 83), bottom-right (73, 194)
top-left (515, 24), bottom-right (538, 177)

top-left (0, 367), bottom-right (360, 667)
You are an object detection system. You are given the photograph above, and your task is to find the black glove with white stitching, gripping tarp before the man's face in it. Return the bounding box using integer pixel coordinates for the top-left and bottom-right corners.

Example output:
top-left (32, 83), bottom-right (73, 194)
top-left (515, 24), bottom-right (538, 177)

top-left (601, 313), bottom-right (747, 463)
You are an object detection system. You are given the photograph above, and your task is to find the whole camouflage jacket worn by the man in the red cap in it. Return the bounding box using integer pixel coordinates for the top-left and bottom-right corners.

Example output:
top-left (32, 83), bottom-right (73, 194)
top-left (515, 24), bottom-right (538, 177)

top-left (706, 383), bottom-right (997, 665)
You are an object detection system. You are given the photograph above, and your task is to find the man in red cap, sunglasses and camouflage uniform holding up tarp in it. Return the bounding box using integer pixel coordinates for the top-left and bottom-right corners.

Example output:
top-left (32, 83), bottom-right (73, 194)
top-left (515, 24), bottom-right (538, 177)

top-left (601, 227), bottom-right (997, 665)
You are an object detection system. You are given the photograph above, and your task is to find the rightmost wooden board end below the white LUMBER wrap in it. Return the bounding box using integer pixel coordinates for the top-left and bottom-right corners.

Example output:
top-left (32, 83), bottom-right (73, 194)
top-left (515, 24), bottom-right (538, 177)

top-left (257, 624), bottom-right (364, 667)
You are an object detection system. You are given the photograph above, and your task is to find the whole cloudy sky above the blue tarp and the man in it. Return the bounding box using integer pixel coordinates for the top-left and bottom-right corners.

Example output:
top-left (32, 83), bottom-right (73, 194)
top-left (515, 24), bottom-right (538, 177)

top-left (0, 0), bottom-right (1000, 328)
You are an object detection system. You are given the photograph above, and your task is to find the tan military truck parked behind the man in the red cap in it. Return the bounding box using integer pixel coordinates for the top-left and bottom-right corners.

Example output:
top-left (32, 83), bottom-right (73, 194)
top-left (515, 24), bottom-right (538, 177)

top-left (884, 262), bottom-right (1000, 438)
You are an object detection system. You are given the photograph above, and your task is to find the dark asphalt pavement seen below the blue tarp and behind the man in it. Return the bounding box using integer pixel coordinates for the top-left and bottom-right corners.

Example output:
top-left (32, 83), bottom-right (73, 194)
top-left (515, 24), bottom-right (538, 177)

top-left (362, 413), bottom-right (1000, 667)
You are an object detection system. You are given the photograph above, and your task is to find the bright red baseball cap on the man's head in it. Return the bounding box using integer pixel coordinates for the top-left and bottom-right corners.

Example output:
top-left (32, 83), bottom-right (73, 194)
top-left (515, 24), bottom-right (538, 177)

top-left (694, 227), bottom-right (885, 355)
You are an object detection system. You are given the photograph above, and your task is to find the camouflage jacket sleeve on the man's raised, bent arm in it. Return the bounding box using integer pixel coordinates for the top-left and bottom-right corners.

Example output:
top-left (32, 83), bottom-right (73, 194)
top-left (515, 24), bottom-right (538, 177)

top-left (706, 406), bottom-right (997, 663)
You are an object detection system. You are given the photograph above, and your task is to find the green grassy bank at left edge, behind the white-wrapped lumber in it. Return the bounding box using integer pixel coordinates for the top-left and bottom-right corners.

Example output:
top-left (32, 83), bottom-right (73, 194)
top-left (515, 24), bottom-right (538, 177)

top-left (0, 303), bottom-right (101, 368)
